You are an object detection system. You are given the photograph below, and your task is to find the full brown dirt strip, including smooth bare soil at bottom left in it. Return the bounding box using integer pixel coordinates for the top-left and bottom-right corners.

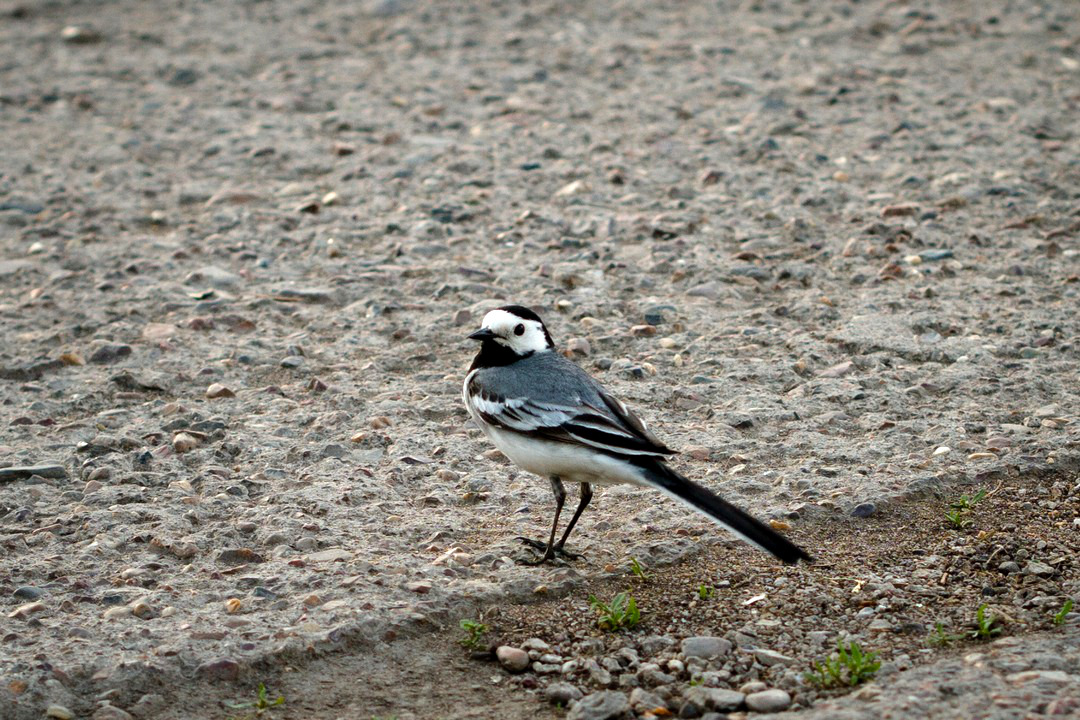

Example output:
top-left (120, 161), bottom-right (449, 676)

top-left (145, 475), bottom-right (1080, 720)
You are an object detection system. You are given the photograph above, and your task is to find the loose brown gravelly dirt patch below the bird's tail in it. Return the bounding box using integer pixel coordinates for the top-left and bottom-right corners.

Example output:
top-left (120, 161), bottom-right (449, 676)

top-left (484, 476), bottom-right (1080, 711)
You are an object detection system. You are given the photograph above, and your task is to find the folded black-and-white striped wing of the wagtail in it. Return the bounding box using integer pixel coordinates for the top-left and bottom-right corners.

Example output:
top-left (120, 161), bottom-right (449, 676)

top-left (468, 373), bottom-right (675, 457)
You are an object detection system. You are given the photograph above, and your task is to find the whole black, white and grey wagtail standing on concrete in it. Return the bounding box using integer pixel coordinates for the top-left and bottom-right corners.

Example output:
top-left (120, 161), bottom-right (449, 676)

top-left (462, 305), bottom-right (811, 562)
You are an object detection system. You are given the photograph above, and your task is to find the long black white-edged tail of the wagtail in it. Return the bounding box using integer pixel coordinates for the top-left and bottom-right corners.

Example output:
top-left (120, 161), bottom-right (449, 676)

top-left (631, 458), bottom-right (813, 563)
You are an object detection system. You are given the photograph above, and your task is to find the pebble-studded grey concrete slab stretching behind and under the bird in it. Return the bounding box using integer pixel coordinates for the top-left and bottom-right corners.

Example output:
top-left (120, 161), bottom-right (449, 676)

top-left (0, 0), bottom-right (1080, 719)
